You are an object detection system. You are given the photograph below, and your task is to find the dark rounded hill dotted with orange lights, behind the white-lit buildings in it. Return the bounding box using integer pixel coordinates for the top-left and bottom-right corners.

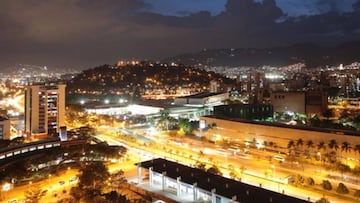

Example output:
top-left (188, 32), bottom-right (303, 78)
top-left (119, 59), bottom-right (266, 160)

top-left (67, 62), bottom-right (234, 93)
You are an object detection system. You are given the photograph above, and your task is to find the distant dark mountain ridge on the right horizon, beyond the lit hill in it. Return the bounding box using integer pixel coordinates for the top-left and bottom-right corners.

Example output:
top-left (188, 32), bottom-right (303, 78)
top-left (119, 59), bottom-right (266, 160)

top-left (163, 41), bottom-right (360, 67)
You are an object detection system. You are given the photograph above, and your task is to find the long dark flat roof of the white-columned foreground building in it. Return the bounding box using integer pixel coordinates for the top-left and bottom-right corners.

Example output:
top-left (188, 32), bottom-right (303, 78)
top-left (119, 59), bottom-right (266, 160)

top-left (137, 158), bottom-right (308, 203)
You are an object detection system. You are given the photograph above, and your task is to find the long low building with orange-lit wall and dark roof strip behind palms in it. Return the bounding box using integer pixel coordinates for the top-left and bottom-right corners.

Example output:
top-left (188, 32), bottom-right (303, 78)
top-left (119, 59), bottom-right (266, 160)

top-left (200, 116), bottom-right (360, 168)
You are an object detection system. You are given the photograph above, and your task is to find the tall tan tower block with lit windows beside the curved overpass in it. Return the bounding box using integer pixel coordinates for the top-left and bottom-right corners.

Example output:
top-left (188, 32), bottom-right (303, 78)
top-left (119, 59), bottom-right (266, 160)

top-left (25, 83), bottom-right (66, 135)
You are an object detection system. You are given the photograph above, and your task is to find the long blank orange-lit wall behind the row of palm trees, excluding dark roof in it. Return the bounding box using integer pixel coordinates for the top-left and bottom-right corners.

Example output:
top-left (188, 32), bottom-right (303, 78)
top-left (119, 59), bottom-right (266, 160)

top-left (200, 117), bottom-right (360, 166)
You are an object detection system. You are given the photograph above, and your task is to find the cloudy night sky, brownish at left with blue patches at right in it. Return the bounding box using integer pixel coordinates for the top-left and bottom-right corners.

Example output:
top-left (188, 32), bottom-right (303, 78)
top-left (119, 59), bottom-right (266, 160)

top-left (0, 0), bottom-right (360, 70)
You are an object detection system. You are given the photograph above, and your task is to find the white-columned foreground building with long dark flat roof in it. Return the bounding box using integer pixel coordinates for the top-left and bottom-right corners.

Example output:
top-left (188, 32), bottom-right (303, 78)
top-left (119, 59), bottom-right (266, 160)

top-left (137, 158), bottom-right (308, 203)
